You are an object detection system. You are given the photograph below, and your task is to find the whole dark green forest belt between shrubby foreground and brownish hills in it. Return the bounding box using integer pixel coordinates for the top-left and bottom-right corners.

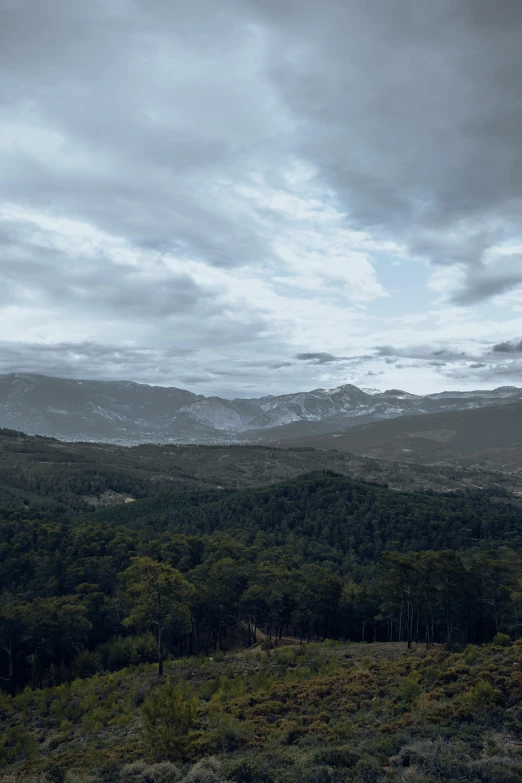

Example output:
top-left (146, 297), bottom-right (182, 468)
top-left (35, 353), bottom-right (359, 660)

top-left (0, 474), bottom-right (522, 693)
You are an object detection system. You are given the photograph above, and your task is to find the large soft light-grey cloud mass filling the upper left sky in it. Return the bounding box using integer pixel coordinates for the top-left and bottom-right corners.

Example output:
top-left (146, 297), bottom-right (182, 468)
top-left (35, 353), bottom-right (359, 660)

top-left (0, 0), bottom-right (277, 266)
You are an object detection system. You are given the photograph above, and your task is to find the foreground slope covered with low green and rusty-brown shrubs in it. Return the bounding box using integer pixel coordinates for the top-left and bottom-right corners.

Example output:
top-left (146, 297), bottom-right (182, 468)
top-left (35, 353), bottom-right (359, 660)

top-left (0, 644), bottom-right (522, 783)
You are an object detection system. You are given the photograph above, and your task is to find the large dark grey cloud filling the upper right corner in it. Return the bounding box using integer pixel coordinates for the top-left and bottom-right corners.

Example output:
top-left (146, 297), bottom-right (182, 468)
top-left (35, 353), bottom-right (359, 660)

top-left (246, 0), bottom-right (522, 304)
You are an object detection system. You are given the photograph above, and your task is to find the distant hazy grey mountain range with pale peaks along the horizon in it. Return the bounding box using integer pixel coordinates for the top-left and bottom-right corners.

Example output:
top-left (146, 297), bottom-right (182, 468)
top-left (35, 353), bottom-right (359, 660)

top-left (0, 373), bottom-right (522, 444)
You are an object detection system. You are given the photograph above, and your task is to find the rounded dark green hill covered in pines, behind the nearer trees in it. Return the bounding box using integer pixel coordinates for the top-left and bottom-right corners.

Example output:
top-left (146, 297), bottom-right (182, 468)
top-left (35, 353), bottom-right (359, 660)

top-left (90, 472), bottom-right (522, 561)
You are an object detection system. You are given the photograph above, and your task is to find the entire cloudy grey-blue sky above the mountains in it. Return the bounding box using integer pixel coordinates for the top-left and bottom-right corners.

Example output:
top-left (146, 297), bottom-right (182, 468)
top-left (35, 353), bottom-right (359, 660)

top-left (0, 0), bottom-right (522, 397)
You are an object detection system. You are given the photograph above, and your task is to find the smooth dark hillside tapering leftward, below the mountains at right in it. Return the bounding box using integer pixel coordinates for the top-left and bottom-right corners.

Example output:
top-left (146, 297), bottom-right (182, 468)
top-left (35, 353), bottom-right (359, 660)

top-left (280, 403), bottom-right (522, 475)
